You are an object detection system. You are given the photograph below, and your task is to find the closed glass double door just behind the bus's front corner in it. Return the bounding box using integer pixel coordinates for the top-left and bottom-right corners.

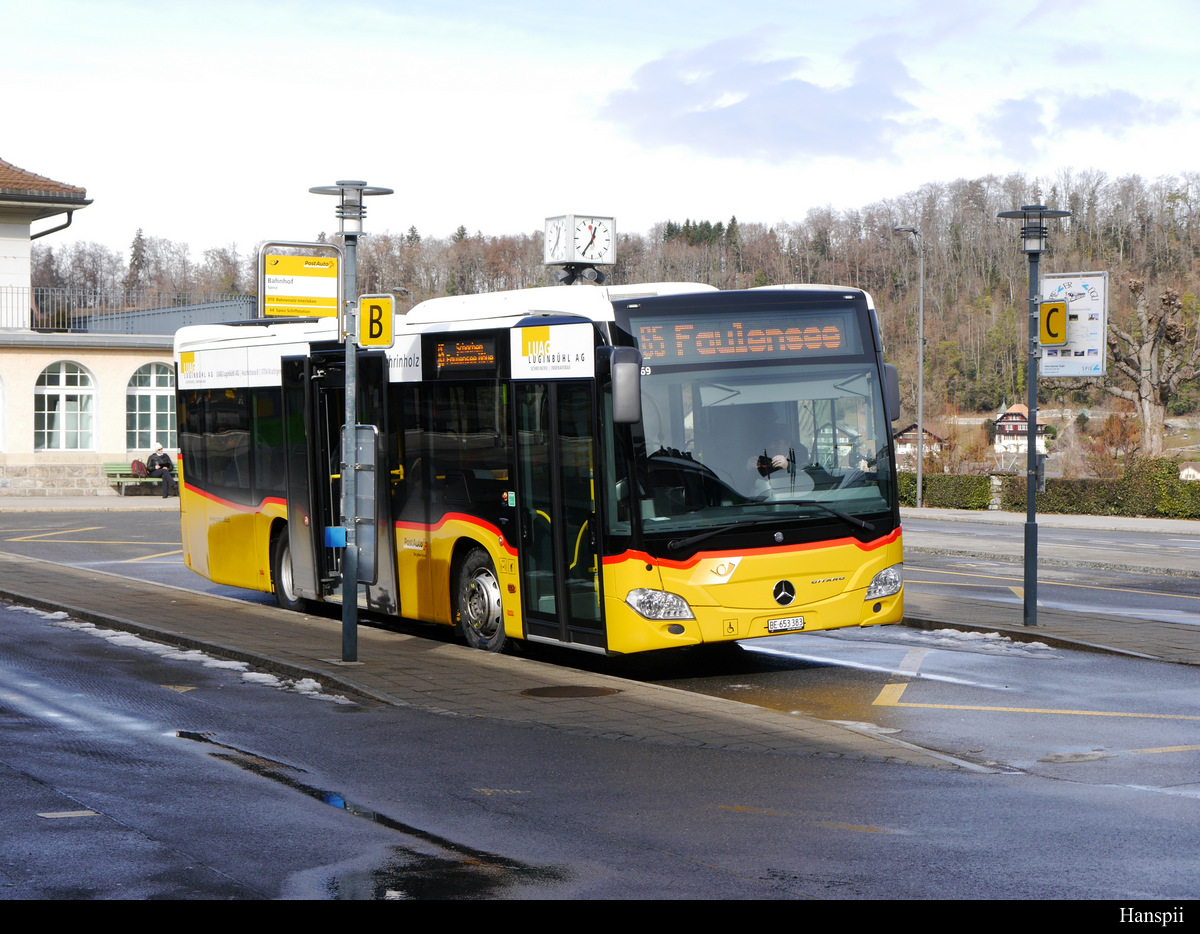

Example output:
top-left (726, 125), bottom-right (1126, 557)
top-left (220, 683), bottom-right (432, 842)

top-left (515, 381), bottom-right (607, 649)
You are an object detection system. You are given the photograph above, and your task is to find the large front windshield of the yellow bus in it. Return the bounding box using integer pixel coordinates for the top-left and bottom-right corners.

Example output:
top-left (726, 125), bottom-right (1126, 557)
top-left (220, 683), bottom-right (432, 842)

top-left (635, 361), bottom-right (895, 535)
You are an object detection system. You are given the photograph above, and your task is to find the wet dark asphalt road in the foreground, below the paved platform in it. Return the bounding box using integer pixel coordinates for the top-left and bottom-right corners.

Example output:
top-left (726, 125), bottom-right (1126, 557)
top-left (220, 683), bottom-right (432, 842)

top-left (0, 600), bottom-right (1200, 897)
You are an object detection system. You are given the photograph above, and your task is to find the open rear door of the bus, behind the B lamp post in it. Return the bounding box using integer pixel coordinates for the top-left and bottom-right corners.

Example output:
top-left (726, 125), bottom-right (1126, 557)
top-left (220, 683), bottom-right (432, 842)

top-left (283, 352), bottom-right (400, 615)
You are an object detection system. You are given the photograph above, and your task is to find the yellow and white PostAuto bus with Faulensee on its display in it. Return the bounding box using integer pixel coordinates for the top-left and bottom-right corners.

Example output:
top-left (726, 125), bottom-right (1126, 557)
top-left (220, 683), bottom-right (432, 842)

top-left (175, 283), bottom-right (904, 653)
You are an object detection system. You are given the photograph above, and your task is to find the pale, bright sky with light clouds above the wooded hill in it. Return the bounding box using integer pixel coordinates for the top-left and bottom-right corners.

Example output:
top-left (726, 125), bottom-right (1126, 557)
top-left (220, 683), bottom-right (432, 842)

top-left (0, 0), bottom-right (1200, 257)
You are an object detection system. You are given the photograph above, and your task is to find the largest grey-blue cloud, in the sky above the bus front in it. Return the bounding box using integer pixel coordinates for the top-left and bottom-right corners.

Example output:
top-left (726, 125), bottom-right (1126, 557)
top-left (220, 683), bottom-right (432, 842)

top-left (602, 36), bottom-right (913, 163)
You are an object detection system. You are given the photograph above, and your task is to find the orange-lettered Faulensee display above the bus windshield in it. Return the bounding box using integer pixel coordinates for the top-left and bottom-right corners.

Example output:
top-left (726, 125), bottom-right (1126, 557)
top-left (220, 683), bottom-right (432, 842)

top-left (632, 311), bottom-right (863, 365)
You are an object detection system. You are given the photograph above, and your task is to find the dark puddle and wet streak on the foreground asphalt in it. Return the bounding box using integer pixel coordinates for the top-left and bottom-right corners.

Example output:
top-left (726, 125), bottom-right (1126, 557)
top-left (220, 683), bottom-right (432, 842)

top-left (175, 730), bottom-right (568, 899)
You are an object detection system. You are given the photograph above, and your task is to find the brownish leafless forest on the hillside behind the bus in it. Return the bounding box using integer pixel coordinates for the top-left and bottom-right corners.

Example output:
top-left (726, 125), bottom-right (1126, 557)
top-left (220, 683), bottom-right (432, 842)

top-left (32, 170), bottom-right (1200, 439)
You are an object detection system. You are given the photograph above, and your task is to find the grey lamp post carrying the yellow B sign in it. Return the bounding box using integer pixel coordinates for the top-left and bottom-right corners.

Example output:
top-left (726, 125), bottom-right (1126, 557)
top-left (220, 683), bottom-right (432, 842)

top-left (308, 181), bottom-right (392, 661)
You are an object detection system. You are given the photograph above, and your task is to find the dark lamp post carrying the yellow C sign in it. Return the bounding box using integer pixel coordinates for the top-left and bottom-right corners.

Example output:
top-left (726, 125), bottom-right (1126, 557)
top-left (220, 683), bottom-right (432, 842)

top-left (997, 204), bottom-right (1070, 625)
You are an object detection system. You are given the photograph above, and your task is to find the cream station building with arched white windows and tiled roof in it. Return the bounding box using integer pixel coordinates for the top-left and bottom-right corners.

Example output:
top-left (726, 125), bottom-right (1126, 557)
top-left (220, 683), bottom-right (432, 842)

top-left (0, 160), bottom-right (253, 497)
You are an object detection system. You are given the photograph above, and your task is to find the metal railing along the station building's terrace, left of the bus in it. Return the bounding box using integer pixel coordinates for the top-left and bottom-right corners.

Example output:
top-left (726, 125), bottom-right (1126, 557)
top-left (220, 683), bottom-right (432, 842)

top-left (0, 286), bottom-right (257, 335)
